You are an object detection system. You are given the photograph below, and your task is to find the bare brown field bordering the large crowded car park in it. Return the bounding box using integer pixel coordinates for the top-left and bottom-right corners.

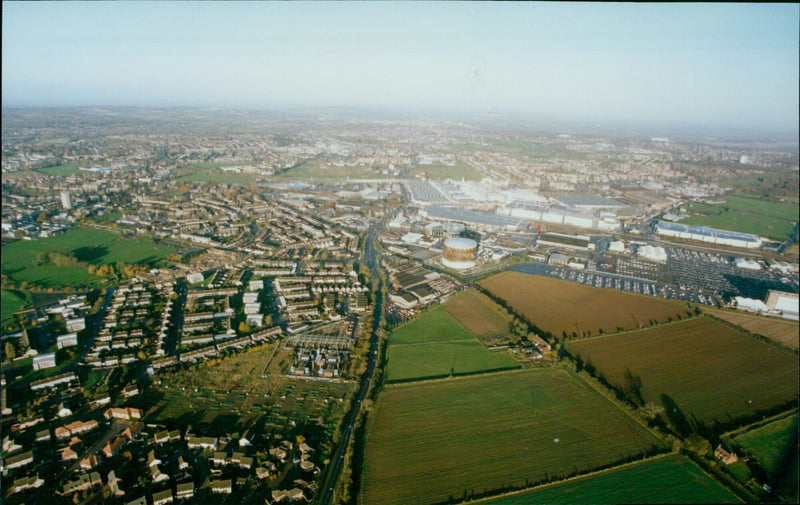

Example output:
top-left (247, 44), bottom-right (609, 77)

top-left (479, 271), bottom-right (690, 337)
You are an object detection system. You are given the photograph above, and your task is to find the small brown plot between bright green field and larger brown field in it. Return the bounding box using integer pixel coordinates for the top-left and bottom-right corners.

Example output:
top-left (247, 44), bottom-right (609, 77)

top-left (443, 289), bottom-right (512, 342)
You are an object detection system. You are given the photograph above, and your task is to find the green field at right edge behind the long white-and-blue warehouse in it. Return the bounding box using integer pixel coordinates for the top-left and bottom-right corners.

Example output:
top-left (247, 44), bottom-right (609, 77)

top-left (681, 195), bottom-right (798, 240)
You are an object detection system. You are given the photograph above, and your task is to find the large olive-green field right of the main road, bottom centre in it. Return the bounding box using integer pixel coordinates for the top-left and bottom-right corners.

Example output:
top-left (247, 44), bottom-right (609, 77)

top-left (363, 369), bottom-right (660, 505)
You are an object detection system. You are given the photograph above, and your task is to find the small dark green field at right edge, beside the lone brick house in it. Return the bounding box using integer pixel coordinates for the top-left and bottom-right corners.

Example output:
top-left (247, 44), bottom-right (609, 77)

top-left (733, 414), bottom-right (798, 475)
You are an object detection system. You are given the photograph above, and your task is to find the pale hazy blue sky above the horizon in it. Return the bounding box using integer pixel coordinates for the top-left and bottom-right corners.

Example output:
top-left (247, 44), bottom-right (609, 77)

top-left (2, 1), bottom-right (800, 132)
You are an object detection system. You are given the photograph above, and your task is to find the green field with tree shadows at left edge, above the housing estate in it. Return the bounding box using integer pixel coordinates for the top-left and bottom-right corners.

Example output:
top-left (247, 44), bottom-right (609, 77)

top-left (2, 228), bottom-right (175, 287)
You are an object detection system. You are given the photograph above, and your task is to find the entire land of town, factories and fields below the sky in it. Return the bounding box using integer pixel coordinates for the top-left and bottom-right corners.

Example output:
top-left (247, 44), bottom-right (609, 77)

top-left (0, 2), bottom-right (800, 505)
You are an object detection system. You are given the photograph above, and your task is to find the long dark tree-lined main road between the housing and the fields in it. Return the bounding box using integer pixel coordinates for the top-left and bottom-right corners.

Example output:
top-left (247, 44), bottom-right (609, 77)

top-left (317, 216), bottom-right (389, 505)
